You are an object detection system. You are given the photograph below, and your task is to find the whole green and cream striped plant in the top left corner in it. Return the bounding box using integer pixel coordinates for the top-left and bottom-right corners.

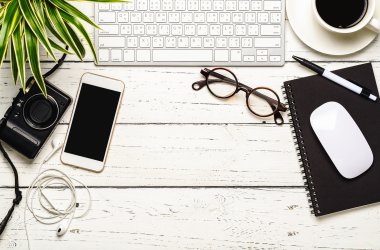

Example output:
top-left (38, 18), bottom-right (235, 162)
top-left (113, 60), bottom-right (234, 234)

top-left (0, 0), bottom-right (127, 95)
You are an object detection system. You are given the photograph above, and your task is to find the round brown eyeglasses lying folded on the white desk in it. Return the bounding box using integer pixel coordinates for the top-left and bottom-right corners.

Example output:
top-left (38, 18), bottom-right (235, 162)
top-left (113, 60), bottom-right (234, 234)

top-left (192, 67), bottom-right (287, 125)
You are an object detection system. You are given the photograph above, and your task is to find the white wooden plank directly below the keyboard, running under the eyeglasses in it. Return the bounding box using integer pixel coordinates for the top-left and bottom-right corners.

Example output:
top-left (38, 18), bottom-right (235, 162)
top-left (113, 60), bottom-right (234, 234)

top-left (0, 62), bottom-right (380, 123)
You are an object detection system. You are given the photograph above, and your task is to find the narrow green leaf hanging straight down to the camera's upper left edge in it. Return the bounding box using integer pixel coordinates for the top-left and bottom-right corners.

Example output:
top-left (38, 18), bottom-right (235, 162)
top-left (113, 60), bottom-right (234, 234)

top-left (12, 22), bottom-right (26, 92)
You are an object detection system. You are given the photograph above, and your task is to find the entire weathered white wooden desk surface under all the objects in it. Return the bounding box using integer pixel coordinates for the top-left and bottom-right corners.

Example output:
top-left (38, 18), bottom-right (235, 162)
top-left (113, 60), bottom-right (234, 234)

top-left (0, 4), bottom-right (380, 250)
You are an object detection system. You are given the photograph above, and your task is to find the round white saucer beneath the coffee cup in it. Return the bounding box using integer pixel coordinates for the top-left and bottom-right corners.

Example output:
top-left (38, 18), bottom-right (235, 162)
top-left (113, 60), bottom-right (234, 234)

top-left (286, 0), bottom-right (380, 56)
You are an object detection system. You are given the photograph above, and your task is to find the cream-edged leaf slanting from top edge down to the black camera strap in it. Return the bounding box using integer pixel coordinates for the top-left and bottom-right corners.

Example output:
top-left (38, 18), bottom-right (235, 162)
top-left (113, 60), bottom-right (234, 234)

top-left (17, 0), bottom-right (57, 61)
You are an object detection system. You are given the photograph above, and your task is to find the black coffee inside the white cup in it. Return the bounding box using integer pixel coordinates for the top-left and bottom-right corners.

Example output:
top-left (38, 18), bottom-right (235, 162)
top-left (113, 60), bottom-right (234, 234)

top-left (316, 0), bottom-right (368, 29)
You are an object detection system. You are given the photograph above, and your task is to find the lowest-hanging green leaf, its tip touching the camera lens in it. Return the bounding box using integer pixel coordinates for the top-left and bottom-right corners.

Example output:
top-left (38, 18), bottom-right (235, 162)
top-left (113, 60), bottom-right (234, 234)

top-left (25, 25), bottom-right (47, 97)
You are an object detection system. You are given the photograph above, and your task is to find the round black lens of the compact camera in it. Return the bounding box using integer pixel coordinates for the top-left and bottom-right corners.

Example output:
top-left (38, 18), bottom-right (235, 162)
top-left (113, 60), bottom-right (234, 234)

top-left (23, 94), bottom-right (59, 130)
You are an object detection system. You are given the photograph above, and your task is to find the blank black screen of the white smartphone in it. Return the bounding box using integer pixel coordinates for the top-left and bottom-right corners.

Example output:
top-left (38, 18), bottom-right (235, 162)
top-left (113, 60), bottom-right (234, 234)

top-left (64, 83), bottom-right (121, 161)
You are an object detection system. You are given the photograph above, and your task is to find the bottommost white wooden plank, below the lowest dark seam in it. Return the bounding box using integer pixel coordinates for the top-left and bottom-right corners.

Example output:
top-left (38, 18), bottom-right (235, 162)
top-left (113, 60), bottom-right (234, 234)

top-left (0, 188), bottom-right (380, 250)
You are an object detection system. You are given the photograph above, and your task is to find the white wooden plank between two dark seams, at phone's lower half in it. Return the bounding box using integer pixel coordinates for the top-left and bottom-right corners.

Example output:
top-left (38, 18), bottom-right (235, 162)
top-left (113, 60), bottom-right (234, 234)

top-left (0, 124), bottom-right (303, 186)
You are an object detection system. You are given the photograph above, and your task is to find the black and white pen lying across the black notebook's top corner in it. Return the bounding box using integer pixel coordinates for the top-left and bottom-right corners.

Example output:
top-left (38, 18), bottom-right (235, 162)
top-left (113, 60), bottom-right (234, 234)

top-left (293, 56), bottom-right (378, 101)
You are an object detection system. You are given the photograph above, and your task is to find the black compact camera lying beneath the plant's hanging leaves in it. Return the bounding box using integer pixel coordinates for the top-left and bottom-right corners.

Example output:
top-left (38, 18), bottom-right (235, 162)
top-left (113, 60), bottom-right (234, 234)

top-left (0, 80), bottom-right (71, 159)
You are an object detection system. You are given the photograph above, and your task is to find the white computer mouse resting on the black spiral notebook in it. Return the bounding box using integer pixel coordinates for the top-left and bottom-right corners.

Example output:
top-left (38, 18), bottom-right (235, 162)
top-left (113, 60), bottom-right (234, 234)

top-left (310, 102), bottom-right (373, 179)
